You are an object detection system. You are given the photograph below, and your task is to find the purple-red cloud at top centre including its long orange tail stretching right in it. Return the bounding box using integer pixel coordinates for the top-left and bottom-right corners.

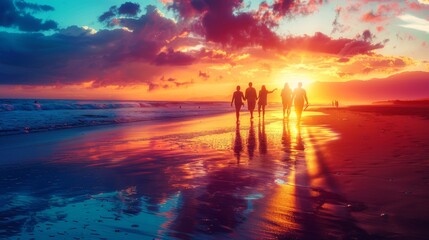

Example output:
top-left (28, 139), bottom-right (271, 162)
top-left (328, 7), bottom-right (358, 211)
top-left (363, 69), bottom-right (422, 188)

top-left (169, 0), bottom-right (384, 56)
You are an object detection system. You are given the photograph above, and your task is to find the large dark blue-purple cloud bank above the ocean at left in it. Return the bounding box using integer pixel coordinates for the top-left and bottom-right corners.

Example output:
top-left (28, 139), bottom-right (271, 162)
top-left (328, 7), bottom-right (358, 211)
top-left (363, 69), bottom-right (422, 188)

top-left (0, 7), bottom-right (190, 86)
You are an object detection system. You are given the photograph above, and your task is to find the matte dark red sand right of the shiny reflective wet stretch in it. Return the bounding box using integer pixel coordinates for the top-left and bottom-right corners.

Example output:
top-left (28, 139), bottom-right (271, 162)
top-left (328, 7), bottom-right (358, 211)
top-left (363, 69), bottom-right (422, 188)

top-left (307, 106), bottom-right (429, 239)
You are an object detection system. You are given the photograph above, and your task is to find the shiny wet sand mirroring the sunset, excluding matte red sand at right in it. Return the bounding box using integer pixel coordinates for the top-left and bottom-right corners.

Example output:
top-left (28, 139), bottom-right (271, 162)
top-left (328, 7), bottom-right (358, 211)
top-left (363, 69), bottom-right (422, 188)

top-left (0, 111), bottom-right (374, 239)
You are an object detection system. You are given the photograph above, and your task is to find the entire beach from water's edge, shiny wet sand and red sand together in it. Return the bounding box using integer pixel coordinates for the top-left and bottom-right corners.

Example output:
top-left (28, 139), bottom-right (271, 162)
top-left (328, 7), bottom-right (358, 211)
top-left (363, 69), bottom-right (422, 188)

top-left (0, 109), bottom-right (429, 239)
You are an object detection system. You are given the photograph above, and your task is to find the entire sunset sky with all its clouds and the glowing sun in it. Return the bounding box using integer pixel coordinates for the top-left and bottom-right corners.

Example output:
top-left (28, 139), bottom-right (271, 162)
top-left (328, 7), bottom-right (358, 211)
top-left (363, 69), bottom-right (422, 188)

top-left (0, 0), bottom-right (429, 101)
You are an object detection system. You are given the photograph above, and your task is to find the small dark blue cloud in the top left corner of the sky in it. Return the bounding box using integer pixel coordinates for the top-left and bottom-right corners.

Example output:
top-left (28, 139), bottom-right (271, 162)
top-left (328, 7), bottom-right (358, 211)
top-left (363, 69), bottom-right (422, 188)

top-left (0, 0), bottom-right (58, 32)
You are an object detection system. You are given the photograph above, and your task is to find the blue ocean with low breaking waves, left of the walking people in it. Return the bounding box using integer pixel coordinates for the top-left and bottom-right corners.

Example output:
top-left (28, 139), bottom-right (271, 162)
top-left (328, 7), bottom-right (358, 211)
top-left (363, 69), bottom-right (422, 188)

top-left (0, 99), bottom-right (233, 136)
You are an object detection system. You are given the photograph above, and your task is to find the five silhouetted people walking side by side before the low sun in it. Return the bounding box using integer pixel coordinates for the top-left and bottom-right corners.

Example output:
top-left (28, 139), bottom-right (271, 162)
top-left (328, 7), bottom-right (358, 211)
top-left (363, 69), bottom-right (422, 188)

top-left (231, 82), bottom-right (308, 125)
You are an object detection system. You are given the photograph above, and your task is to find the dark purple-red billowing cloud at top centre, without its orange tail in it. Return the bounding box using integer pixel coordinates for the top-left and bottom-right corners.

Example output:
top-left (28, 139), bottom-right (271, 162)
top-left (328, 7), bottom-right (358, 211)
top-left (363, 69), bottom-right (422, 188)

top-left (169, 0), bottom-right (279, 48)
